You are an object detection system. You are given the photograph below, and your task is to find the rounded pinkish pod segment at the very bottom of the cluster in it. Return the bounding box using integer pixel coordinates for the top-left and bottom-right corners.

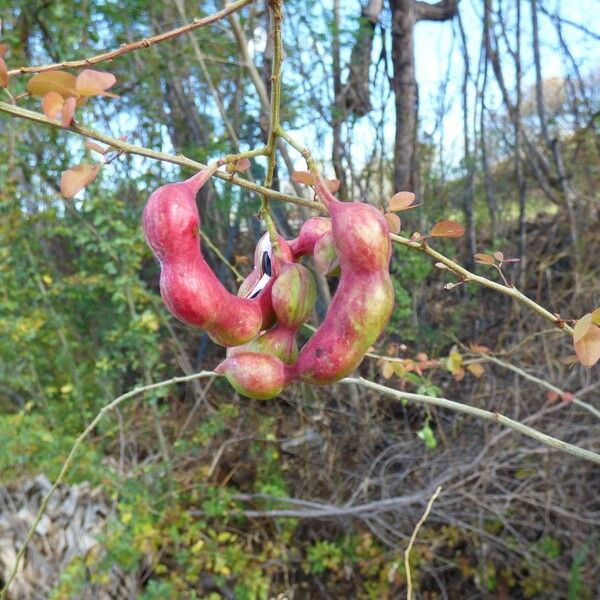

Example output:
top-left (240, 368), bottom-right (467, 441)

top-left (215, 352), bottom-right (290, 400)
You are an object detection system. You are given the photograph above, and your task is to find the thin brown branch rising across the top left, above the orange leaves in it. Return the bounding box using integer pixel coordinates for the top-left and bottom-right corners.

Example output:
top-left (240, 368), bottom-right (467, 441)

top-left (8, 0), bottom-right (255, 76)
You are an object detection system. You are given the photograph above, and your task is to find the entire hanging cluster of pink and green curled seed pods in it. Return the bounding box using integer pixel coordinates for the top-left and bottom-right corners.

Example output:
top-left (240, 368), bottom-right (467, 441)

top-left (142, 168), bottom-right (394, 399)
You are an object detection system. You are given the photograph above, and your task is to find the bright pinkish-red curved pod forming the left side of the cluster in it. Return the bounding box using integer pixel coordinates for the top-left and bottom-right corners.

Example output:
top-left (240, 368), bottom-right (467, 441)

top-left (142, 166), bottom-right (263, 346)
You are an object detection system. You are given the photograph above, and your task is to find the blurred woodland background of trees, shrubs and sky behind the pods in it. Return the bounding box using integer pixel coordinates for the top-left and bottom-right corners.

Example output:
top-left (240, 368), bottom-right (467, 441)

top-left (0, 0), bottom-right (600, 599)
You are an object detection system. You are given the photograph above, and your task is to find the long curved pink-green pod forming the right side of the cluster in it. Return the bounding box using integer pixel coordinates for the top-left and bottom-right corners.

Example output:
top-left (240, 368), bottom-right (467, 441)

top-left (295, 179), bottom-right (394, 384)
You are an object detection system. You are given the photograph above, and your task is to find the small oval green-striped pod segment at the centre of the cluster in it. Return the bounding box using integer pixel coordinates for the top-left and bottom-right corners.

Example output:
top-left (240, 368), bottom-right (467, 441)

top-left (271, 263), bottom-right (317, 329)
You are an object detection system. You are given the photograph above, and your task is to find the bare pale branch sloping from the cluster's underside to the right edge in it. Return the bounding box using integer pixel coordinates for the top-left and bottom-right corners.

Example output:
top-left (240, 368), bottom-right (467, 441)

top-left (340, 377), bottom-right (600, 465)
